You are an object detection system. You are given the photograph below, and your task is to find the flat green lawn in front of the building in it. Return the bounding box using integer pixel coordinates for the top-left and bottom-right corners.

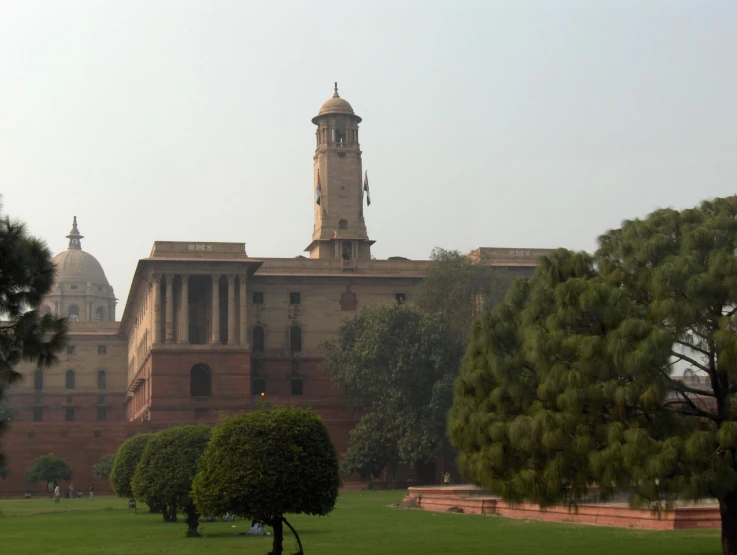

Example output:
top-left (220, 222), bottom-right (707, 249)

top-left (0, 492), bottom-right (721, 555)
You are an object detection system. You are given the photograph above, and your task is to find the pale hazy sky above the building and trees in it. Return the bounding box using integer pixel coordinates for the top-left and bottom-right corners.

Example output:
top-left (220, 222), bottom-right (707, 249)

top-left (0, 0), bottom-right (737, 312)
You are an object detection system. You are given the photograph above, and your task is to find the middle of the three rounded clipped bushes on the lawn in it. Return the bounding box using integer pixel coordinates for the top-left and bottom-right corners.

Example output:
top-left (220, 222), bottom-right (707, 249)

top-left (131, 425), bottom-right (210, 537)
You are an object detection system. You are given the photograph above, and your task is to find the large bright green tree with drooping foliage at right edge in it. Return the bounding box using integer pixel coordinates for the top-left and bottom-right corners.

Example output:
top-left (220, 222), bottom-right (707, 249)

top-left (450, 197), bottom-right (737, 555)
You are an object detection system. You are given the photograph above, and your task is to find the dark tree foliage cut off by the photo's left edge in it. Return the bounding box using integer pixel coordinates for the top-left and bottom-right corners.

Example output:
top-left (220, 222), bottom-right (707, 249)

top-left (0, 198), bottom-right (66, 472)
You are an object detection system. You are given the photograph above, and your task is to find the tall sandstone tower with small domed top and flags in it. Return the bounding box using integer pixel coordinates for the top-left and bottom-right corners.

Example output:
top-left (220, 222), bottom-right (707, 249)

top-left (305, 83), bottom-right (374, 263)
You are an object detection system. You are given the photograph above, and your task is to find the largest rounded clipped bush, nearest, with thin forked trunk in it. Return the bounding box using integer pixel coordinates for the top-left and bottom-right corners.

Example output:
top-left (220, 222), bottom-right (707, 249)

top-left (192, 407), bottom-right (340, 555)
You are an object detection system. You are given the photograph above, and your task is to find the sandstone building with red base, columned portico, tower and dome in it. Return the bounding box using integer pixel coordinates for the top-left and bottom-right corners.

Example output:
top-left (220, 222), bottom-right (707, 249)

top-left (0, 85), bottom-right (548, 500)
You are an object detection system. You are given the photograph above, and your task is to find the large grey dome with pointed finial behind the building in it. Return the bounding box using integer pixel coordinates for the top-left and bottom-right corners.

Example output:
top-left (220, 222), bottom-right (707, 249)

top-left (41, 216), bottom-right (116, 322)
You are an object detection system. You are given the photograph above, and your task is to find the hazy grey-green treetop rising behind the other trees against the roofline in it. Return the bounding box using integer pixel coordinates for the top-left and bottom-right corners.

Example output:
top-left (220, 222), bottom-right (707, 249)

top-left (412, 247), bottom-right (513, 345)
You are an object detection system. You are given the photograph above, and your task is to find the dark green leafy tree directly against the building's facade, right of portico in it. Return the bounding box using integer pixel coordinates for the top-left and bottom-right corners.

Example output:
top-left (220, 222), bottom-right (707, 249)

top-left (322, 304), bottom-right (461, 480)
